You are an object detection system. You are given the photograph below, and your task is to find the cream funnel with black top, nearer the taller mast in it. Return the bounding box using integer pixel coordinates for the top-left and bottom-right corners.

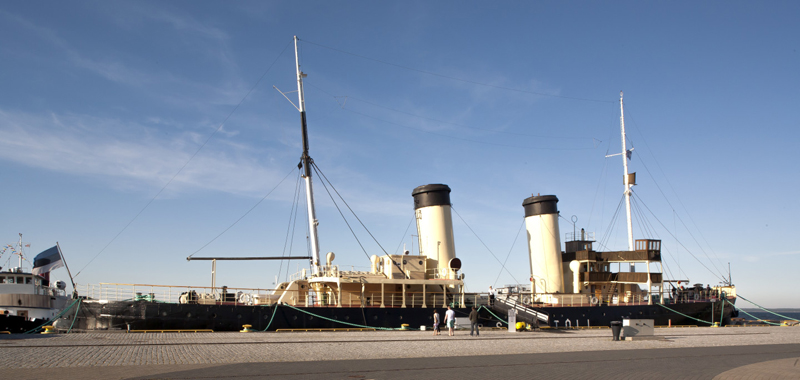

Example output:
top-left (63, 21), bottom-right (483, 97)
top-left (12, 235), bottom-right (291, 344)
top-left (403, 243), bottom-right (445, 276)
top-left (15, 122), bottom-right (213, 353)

top-left (411, 184), bottom-right (460, 278)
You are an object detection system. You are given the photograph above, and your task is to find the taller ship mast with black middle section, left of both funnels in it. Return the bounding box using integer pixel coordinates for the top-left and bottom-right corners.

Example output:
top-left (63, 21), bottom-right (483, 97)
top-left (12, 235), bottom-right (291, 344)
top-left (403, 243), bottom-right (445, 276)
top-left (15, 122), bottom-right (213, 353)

top-left (294, 36), bottom-right (319, 275)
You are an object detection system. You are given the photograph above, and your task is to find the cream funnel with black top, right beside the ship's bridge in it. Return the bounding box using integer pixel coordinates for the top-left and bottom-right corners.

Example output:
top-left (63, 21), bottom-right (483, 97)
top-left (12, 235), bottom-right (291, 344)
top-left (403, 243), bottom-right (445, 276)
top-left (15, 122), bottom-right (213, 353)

top-left (522, 195), bottom-right (564, 293)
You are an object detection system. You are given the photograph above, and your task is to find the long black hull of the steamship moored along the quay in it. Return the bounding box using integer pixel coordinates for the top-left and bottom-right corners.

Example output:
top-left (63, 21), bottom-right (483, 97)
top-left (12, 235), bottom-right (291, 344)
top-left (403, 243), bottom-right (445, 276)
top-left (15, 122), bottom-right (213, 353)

top-left (65, 301), bottom-right (736, 331)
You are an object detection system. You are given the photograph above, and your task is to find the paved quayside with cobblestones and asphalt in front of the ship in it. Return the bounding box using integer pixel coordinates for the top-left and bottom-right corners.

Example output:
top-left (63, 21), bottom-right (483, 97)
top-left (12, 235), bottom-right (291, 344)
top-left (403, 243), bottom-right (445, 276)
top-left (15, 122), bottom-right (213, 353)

top-left (0, 327), bottom-right (800, 379)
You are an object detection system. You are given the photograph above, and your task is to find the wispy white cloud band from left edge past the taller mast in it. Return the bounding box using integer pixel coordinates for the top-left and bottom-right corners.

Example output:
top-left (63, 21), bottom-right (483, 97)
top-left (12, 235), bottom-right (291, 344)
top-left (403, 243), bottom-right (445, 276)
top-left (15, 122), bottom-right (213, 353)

top-left (0, 109), bottom-right (422, 221)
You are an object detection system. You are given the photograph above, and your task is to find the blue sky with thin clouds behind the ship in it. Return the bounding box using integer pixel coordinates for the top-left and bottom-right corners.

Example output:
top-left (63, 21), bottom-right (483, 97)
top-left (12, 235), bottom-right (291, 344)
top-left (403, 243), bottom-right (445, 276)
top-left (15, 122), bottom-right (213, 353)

top-left (0, 1), bottom-right (800, 307)
